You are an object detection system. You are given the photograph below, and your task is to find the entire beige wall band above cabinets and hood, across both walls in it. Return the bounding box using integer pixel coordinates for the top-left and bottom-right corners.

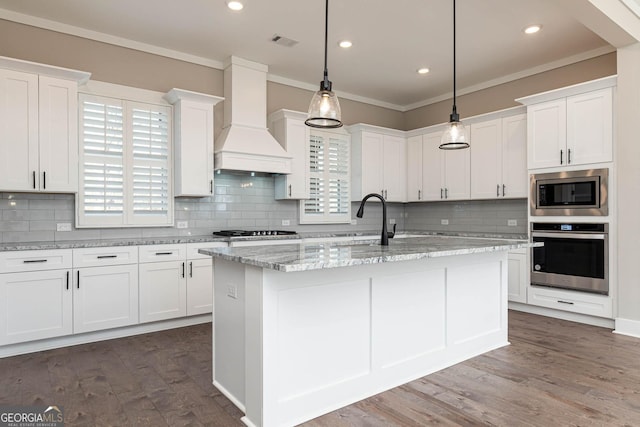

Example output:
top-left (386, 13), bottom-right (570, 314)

top-left (0, 20), bottom-right (616, 133)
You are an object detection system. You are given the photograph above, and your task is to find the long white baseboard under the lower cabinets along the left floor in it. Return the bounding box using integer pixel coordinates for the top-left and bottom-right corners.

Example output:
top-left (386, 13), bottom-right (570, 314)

top-left (0, 314), bottom-right (212, 358)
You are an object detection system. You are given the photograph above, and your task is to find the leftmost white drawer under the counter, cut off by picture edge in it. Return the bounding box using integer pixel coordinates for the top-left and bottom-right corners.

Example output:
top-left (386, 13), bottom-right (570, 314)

top-left (0, 249), bottom-right (72, 273)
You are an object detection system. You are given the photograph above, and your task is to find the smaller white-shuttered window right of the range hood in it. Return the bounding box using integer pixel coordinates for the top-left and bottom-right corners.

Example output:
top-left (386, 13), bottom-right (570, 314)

top-left (300, 130), bottom-right (351, 224)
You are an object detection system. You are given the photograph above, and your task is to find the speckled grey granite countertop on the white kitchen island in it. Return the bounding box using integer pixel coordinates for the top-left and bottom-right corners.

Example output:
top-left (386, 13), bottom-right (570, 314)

top-left (199, 236), bottom-right (541, 272)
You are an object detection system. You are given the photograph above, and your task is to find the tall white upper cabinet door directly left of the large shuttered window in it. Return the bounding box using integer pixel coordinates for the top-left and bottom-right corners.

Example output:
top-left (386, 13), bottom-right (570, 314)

top-left (38, 76), bottom-right (78, 193)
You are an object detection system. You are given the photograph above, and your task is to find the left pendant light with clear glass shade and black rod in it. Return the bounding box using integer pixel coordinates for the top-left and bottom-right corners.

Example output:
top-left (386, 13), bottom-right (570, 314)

top-left (304, 0), bottom-right (342, 128)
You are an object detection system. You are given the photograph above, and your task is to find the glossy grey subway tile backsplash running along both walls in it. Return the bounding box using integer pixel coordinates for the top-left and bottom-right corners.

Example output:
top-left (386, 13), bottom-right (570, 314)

top-left (0, 173), bottom-right (527, 243)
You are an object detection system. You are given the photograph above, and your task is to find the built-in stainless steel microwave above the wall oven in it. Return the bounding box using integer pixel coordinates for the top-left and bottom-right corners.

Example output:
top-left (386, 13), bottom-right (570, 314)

top-left (529, 168), bottom-right (609, 216)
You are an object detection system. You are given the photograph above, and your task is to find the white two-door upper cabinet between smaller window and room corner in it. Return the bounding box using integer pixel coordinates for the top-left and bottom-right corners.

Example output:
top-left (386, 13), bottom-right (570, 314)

top-left (349, 124), bottom-right (407, 202)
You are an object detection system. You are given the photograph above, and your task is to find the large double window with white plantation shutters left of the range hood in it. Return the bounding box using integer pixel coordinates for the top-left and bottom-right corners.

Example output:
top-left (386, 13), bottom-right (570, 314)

top-left (76, 94), bottom-right (173, 227)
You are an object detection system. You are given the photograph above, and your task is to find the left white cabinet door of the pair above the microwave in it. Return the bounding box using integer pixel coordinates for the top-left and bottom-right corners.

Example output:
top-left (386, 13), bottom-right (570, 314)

top-left (527, 99), bottom-right (567, 169)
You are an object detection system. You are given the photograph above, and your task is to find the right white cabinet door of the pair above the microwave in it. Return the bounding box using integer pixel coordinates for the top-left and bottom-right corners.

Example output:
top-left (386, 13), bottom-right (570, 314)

top-left (567, 88), bottom-right (613, 165)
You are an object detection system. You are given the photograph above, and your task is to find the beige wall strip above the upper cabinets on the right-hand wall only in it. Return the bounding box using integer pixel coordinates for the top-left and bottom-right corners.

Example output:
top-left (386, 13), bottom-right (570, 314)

top-left (403, 52), bottom-right (616, 130)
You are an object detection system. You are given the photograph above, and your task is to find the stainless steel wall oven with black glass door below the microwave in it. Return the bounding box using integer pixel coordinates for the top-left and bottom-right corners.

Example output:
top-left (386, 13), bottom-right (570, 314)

top-left (531, 223), bottom-right (609, 295)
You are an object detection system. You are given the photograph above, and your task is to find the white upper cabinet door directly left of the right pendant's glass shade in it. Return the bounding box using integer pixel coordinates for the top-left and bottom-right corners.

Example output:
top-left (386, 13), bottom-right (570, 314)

top-left (422, 132), bottom-right (444, 200)
